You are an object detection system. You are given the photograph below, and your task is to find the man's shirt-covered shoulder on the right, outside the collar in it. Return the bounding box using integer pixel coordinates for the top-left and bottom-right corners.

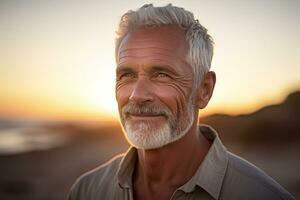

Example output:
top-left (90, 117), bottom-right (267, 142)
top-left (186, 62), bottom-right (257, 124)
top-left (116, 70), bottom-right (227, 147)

top-left (222, 153), bottom-right (293, 199)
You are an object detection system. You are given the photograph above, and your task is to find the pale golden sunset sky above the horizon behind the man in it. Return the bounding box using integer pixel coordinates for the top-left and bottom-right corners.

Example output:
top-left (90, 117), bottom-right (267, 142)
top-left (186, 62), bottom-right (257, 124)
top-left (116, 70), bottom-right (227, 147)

top-left (0, 0), bottom-right (300, 120)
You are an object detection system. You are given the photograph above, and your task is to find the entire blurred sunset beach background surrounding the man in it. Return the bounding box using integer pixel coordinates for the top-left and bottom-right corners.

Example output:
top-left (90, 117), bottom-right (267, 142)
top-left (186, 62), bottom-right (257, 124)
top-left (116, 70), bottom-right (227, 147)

top-left (0, 0), bottom-right (300, 200)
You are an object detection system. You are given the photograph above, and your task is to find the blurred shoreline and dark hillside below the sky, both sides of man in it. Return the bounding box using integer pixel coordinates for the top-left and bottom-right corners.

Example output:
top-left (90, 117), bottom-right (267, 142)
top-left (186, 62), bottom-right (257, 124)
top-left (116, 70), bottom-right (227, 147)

top-left (0, 91), bottom-right (300, 200)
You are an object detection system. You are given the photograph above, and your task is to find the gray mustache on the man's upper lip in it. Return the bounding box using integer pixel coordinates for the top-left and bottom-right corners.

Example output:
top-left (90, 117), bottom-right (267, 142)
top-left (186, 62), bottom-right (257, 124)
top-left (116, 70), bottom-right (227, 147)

top-left (122, 103), bottom-right (172, 117)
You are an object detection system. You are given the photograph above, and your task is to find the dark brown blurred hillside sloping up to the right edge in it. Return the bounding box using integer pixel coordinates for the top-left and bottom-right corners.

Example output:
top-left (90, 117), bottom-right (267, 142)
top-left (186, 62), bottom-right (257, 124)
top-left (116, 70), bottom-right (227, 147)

top-left (200, 91), bottom-right (300, 148)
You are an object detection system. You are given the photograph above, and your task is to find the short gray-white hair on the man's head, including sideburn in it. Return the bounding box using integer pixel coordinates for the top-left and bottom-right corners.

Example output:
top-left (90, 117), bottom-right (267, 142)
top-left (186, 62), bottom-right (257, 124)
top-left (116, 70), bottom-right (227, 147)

top-left (115, 4), bottom-right (214, 87)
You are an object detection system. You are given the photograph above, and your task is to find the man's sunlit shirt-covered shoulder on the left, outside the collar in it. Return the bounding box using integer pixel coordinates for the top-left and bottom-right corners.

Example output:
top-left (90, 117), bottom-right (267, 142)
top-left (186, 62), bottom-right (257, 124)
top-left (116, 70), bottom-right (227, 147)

top-left (69, 154), bottom-right (124, 199)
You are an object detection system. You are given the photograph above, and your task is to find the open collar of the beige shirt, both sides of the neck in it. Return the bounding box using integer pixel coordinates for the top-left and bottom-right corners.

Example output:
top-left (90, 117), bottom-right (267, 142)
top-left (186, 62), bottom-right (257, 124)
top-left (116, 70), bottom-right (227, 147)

top-left (118, 125), bottom-right (228, 199)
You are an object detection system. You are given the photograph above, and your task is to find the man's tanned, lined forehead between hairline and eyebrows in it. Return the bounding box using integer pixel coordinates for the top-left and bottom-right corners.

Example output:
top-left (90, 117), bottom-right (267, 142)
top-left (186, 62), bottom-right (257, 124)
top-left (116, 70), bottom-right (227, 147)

top-left (117, 26), bottom-right (188, 57)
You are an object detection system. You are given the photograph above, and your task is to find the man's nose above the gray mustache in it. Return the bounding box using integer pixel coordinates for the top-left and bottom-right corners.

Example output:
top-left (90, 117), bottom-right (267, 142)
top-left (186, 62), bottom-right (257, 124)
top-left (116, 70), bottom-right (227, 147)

top-left (129, 78), bottom-right (154, 104)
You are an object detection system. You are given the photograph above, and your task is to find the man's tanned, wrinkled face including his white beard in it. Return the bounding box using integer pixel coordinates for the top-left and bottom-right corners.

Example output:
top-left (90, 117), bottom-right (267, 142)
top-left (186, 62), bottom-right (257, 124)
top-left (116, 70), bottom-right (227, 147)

top-left (116, 26), bottom-right (194, 149)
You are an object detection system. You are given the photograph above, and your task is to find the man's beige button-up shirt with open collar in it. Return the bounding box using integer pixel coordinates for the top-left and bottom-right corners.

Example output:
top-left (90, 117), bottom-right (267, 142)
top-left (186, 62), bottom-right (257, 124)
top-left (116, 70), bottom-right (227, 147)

top-left (69, 126), bottom-right (294, 200)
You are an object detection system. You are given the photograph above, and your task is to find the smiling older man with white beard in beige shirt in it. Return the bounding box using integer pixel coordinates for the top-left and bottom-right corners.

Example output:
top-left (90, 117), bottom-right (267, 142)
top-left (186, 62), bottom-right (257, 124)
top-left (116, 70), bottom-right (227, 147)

top-left (69, 4), bottom-right (293, 200)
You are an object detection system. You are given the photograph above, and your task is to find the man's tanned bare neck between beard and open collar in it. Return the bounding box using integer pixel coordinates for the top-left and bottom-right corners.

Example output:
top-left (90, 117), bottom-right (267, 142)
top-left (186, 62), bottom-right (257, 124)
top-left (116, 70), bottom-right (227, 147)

top-left (134, 123), bottom-right (210, 188)
